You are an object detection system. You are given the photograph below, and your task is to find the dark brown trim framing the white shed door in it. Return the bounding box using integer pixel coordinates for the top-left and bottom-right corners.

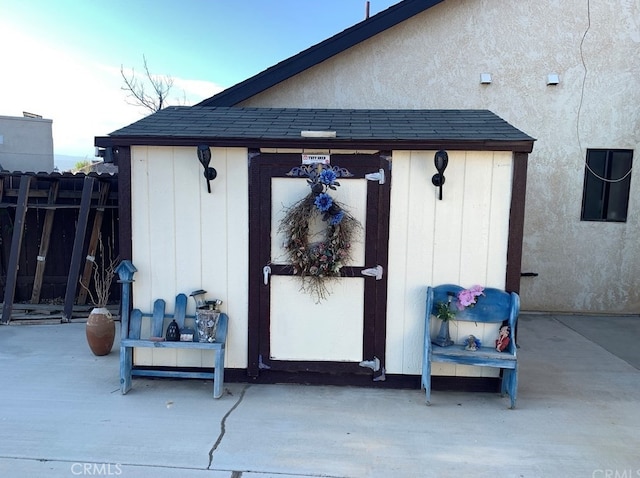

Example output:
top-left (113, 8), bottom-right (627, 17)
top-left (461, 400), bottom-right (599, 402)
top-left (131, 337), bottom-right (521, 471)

top-left (248, 153), bottom-right (390, 377)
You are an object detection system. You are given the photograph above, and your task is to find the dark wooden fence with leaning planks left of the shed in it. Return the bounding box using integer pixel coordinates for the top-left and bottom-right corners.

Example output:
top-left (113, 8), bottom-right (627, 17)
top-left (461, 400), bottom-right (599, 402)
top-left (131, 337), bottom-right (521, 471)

top-left (0, 171), bottom-right (120, 323)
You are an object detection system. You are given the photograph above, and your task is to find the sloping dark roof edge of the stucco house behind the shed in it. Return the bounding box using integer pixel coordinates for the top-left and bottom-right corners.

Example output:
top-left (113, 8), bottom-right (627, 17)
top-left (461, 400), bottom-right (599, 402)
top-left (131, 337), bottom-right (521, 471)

top-left (196, 0), bottom-right (443, 106)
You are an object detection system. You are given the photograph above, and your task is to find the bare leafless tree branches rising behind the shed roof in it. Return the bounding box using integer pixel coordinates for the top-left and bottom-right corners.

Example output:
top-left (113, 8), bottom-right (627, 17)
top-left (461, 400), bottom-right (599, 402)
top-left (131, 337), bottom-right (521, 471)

top-left (120, 55), bottom-right (173, 113)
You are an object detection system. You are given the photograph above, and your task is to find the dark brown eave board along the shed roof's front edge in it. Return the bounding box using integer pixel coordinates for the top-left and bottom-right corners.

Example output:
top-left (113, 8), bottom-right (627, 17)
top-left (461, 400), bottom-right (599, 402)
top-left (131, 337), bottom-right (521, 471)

top-left (95, 135), bottom-right (535, 153)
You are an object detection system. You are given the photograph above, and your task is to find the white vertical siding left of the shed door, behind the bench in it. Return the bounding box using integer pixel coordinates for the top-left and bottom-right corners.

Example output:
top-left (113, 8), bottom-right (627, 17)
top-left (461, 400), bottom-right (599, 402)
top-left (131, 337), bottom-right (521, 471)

top-left (131, 147), bottom-right (248, 368)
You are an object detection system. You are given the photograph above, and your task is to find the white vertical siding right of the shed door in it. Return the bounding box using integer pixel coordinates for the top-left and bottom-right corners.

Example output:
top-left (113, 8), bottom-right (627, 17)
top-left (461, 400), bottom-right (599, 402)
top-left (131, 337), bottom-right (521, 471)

top-left (386, 151), bottom-right (512, 376)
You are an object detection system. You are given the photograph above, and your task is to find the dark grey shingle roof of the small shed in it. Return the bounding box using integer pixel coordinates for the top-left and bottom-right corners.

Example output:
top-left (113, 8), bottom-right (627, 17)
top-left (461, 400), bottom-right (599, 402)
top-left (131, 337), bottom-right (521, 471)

top-left (96, 106), bottom-right (534, 151)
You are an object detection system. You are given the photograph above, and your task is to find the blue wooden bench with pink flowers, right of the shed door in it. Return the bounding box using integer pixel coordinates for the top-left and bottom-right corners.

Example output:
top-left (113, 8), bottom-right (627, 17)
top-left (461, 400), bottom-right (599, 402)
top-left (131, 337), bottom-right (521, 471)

top-left (422, 284), bottom-right (520, 408)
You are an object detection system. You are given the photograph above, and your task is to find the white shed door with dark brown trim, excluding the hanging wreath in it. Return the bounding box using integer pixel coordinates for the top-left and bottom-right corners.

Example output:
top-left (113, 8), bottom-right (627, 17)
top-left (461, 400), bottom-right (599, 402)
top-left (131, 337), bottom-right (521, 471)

top-left (248, 153), bottom-right (391, 383)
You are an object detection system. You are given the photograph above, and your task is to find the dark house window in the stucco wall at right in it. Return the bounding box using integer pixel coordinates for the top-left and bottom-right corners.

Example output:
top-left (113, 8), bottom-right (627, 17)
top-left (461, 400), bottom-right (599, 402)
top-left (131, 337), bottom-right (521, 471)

top-left (581, 149), bottom-right (633, 222)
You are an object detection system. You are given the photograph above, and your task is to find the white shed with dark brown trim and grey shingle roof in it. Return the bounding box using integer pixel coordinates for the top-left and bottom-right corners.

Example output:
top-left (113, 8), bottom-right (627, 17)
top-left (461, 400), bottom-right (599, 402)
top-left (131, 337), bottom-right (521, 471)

top-left (96, 106), bottom-right (534, 386)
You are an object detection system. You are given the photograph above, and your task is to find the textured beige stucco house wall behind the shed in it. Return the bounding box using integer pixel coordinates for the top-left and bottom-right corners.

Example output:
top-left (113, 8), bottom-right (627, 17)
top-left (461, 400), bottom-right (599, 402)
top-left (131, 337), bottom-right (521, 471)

top-left (240, 0), bottom-right (640, 313)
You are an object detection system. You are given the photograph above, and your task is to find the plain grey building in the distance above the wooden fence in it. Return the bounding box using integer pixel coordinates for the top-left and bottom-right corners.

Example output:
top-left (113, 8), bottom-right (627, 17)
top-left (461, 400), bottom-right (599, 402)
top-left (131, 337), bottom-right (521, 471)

top-left (0, 116), bottom-right (54, 173)
